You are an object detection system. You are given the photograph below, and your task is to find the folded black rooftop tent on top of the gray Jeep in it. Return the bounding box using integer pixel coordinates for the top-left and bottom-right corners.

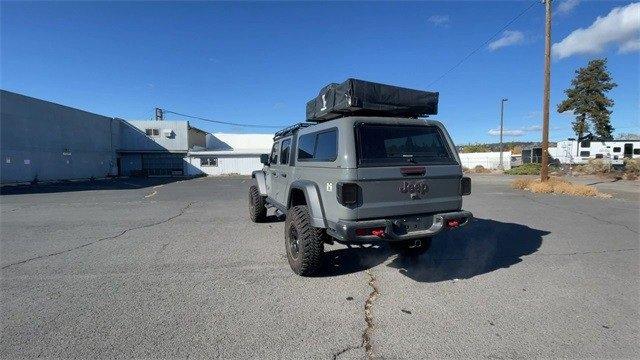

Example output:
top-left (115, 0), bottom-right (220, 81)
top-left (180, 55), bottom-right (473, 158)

top-left (307, 79), bottom-right (438, 121)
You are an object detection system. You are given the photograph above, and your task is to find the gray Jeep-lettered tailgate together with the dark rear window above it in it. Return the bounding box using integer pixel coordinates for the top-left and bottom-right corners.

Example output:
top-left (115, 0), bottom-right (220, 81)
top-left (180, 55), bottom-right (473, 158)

top-left (356, 123), bottom-right (462, 219)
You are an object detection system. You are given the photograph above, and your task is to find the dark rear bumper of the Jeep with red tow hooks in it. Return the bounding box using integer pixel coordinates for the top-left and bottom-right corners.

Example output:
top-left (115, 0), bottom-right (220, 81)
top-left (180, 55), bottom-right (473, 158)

top-left (330, 210), bottom-right (473, 243)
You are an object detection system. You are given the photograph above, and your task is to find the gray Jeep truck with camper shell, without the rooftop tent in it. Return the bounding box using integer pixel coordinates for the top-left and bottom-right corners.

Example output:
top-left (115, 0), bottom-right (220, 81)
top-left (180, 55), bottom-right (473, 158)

top-left (249, 79), bottom-right (472, 276)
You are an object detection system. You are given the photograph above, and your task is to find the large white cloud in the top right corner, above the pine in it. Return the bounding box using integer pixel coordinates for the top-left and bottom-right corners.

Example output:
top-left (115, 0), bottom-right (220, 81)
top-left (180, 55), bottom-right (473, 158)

top-left (551, 2), bottom-right (640, 59)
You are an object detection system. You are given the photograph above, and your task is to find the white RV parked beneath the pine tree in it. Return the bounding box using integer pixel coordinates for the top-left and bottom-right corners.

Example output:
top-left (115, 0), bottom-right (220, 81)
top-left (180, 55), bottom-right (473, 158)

top-left (549, 134), bottom-right (640, 165)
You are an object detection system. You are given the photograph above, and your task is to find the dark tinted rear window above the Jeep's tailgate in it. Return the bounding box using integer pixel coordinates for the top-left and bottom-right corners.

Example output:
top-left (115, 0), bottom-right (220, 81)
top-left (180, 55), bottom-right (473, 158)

top-left (357, 124), bottom-right (455, 166)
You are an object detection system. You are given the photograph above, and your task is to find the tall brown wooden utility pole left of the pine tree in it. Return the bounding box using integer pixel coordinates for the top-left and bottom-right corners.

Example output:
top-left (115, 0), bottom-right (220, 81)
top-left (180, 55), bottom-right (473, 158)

top-left (540, 0), bottom-right (551, 181)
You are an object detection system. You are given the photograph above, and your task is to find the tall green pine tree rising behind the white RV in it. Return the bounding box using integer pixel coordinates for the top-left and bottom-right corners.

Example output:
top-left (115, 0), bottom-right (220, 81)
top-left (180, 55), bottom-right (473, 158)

top-left (558, 59), bottom-right (618, 139)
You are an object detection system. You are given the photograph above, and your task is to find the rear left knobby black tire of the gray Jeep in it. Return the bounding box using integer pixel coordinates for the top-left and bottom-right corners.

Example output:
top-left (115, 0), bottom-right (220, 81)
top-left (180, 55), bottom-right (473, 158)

top-left (284, 205), bottom-right (324, 276)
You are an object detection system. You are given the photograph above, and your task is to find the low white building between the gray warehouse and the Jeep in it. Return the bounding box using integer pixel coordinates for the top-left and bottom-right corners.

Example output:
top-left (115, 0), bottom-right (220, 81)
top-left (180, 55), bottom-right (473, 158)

top-left (188, 133), bottom-right (273, 176)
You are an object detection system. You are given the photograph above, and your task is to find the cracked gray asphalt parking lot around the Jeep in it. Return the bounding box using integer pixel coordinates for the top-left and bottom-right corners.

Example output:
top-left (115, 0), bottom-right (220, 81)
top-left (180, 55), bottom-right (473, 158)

top-left (0, 176), bottom-right (640, 359)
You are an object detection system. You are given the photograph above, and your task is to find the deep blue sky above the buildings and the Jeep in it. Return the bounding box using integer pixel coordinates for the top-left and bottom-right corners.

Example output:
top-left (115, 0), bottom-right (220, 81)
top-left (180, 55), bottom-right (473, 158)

top-left (0, 0), bottom-right (640, 143)
